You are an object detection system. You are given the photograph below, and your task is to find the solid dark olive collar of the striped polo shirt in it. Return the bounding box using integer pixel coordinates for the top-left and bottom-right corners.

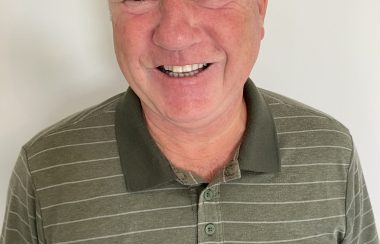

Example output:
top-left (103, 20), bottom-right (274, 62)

top-left (115, 79), bottom-right (280, 191)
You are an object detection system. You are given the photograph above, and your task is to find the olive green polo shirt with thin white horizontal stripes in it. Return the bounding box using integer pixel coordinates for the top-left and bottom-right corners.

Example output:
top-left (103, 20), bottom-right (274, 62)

top-left (0, 80), bottom-right (379, 244)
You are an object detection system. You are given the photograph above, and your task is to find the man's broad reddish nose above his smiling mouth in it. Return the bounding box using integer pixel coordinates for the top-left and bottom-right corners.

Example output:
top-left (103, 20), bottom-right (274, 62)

top-left (153, 0), bottom-right (200, 51)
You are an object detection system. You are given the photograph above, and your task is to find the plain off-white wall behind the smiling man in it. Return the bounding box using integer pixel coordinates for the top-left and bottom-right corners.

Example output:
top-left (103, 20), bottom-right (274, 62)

top-left (0, 0), bottom-right (380, 233)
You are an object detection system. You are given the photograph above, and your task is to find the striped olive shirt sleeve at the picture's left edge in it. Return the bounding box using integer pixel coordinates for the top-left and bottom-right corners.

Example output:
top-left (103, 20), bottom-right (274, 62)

top-left (0, 150), bottom-right (45, 244)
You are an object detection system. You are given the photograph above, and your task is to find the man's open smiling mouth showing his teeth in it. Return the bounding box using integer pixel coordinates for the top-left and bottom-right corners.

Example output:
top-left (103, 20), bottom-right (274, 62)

top-left (157, 63), bottom-right (211, 78)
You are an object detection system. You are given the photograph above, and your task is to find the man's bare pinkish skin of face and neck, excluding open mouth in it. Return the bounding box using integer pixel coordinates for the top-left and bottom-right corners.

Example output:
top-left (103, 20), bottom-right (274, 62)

top-left (109, 0), bottom-right (267, 180)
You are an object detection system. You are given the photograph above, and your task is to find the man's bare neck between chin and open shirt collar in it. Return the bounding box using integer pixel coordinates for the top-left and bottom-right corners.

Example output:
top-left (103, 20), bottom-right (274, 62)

top-left (143, 99), bottom-right (247, 181)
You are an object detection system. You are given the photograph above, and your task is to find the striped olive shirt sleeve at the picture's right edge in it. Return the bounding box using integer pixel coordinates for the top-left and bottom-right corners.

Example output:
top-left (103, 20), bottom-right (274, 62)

top-left (342, 149), bottom-right (379, 244)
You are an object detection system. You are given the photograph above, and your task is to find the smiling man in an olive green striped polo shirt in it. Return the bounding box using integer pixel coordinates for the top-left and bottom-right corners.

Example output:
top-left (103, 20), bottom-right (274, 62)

top-left (1, 0), bottom-right (379, 244)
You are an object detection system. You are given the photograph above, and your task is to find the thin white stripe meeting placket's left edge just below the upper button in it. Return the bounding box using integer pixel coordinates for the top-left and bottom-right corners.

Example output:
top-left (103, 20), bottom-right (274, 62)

top-left (44, 204), bottom-right (197, 229)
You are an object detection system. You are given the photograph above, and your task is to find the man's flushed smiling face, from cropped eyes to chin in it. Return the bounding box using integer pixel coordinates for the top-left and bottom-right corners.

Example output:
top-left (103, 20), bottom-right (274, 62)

top-left (109, 0), bottom-right (267, 124)
